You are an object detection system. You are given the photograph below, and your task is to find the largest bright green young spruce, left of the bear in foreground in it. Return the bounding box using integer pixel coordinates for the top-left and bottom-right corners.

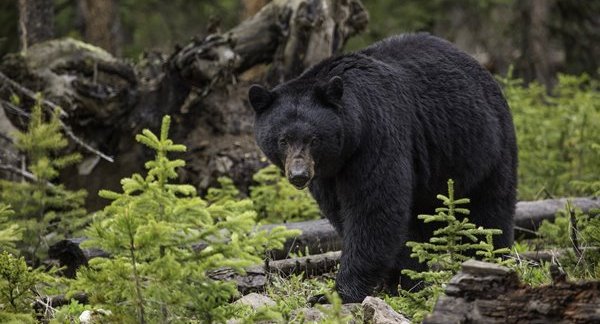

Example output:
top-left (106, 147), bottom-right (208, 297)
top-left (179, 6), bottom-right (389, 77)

top-left (74, 117), bottom-right (298, 322)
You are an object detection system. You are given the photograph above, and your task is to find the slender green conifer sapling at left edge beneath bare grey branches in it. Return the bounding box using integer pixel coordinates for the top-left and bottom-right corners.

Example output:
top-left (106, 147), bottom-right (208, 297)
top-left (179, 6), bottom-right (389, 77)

top-left (0, 96), bottom-right (86, 264)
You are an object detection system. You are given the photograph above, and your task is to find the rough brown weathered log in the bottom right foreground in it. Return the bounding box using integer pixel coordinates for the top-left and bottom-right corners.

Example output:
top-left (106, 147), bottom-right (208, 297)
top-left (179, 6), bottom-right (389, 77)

top-left (423, 260), bottom-right (600, 324)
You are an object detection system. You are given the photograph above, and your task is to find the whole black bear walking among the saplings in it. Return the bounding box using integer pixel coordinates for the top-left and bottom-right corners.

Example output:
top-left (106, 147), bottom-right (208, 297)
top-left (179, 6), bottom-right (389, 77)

top-left (249, 33), bottom-right (517, 302)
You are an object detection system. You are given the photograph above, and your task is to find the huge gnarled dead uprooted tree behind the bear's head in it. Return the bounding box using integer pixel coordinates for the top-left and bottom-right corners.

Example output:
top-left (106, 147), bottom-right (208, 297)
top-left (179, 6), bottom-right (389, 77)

top-left (0, 0), bottom-right (368, 209)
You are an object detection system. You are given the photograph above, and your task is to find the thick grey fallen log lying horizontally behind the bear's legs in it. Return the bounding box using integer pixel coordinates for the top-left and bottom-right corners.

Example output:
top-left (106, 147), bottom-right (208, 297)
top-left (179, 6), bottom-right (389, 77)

top-left (49, 198), bottom-right (600, 275)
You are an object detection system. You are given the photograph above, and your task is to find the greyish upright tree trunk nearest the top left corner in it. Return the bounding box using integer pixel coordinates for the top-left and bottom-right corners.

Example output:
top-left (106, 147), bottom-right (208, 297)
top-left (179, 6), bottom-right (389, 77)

top-left (19, 0), bottom-right (54, 51)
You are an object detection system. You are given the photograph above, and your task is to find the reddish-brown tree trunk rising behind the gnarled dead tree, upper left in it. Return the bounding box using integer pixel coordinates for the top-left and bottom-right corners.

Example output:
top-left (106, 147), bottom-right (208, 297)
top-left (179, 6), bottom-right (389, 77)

top-left (79, 0), bottom-right (122, 55)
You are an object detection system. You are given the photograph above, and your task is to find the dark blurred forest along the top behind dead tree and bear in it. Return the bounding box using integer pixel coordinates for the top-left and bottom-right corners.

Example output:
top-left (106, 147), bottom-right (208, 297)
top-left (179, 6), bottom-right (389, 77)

top-left (0, 0), bottom-right (600, 85)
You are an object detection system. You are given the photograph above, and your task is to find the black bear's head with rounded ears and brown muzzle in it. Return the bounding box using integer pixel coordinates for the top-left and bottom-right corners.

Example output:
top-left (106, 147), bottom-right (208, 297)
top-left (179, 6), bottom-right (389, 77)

top-left (248, 76), bottom-right (344, 189)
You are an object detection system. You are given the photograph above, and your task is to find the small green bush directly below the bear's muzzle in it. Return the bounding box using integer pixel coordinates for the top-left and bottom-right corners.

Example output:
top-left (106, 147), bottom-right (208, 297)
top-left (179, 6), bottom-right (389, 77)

top-left (250, 165), bottom-right (320, 223)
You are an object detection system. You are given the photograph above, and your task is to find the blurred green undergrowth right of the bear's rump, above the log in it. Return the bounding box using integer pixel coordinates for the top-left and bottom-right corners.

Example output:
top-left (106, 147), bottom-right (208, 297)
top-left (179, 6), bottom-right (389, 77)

top-left (499, 73), bottom-right (600, 200)
